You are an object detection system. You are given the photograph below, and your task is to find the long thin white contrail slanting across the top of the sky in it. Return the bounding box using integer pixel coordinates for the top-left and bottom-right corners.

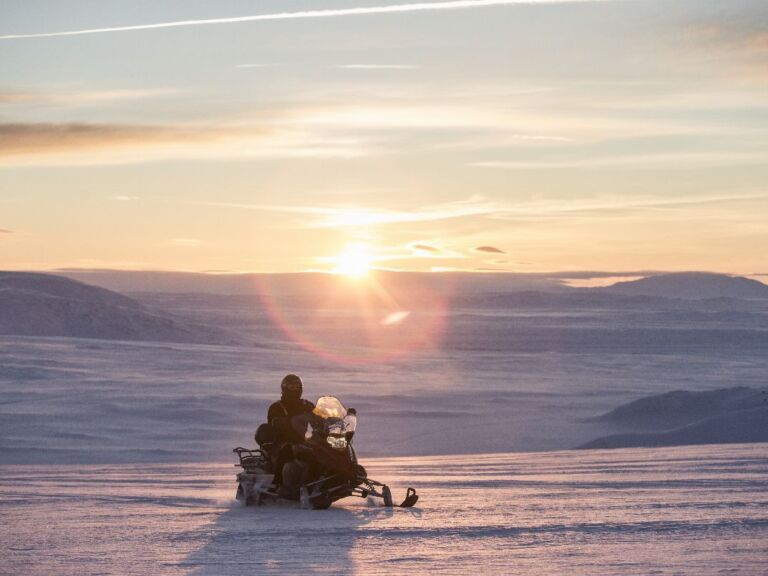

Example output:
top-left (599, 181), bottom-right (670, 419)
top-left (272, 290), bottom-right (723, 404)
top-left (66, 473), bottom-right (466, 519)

top-left (0, 0), bottom-right (609, 40)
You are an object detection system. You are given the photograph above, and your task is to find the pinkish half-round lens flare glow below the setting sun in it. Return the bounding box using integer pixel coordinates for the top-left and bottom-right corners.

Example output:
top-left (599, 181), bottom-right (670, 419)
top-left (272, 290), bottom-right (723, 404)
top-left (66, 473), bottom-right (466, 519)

top-left (256, 272), bottom-right (452, 365)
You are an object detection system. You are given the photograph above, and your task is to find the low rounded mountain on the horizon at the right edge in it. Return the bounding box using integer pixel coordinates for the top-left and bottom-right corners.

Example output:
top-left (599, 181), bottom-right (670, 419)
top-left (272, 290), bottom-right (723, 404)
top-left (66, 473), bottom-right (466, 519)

top-left (593, 272), bottom-right (768, 300)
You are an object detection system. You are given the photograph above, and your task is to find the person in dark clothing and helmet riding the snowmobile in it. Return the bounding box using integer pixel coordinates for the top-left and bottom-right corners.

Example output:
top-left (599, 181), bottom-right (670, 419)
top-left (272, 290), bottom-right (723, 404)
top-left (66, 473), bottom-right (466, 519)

top-left (267, 374), bottom-right (315, 486)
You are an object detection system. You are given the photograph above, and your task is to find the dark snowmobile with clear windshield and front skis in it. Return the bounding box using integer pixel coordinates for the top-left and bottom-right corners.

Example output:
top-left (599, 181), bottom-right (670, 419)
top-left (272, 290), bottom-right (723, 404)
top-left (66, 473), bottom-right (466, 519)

top-left (233, 396), bottom-right (419, 510)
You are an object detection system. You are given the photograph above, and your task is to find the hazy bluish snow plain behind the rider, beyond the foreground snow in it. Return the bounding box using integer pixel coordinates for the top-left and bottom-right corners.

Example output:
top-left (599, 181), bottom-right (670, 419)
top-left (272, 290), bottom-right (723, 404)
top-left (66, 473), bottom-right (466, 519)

top-left (0, 337), bottom-right (768, 464)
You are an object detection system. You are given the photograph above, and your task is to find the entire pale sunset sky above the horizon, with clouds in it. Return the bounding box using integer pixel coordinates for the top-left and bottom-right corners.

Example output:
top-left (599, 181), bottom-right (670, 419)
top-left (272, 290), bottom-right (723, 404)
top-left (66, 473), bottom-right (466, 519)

top-left (0, 0), bottom-right (768, 275)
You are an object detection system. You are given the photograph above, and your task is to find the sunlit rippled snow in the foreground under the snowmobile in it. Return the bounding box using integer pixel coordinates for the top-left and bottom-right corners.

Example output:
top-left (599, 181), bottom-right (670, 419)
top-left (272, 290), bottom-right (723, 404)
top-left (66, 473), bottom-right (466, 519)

top-left (0, 444), bottom-right (768, 576)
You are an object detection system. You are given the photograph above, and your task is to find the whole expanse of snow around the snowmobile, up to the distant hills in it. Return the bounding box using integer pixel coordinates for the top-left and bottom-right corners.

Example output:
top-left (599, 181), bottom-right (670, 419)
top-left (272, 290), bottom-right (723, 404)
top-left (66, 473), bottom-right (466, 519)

top-left (0, 274), bottom-right (768, 576)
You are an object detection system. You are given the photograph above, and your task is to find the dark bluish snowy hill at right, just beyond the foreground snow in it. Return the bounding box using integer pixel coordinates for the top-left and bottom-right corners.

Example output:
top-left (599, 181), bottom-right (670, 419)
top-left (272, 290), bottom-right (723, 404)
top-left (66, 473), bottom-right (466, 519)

top-left (580, 386), bottom-right (768, 448)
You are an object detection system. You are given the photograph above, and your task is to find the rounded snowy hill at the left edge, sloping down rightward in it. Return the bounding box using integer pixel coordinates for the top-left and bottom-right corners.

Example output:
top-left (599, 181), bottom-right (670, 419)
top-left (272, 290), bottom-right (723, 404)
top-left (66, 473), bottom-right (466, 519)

top-left (0, 272), bottom-right (227, 343)
